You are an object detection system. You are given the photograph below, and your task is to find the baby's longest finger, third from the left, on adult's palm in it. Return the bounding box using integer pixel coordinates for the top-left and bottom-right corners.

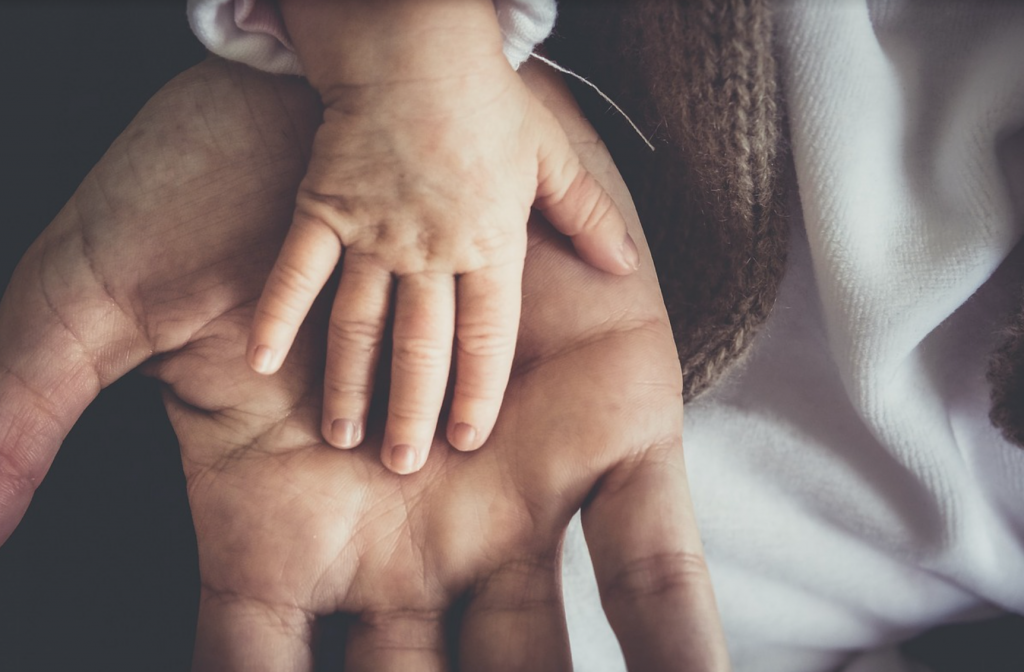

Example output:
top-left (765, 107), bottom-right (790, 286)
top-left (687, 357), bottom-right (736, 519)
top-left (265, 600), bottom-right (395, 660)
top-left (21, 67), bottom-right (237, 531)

top-left (381, 274), bottom-right (455, 473)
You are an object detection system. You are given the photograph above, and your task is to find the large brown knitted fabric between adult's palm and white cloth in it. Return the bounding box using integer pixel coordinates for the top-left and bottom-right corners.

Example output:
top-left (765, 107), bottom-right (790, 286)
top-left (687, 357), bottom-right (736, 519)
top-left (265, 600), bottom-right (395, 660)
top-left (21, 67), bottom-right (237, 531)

top-left (547, 0), bottom-right (792, 400)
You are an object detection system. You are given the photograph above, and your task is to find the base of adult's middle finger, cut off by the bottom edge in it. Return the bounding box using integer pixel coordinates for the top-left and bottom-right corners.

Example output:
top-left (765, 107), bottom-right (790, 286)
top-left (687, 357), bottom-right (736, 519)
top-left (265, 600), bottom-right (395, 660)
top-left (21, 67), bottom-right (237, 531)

top-left (345, 610), bottom-right (450, 672)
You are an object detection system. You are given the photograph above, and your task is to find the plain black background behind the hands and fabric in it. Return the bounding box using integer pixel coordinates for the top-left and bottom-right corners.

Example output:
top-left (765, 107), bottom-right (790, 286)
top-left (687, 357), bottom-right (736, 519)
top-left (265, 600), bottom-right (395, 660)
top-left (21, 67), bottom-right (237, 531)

top-left (0, 0), bottom-right (1024, 672)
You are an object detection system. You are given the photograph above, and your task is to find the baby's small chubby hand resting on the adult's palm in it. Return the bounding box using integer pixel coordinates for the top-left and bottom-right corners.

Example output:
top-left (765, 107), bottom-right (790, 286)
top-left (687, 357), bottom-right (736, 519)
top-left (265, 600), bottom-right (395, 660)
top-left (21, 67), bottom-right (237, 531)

top-left (248, 0), bottom-right (639, 473)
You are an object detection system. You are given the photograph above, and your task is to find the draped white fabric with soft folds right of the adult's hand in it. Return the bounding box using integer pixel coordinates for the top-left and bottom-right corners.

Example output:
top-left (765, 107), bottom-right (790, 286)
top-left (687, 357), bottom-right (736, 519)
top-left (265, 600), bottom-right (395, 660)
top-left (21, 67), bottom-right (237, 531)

top-left (564, 0), bottom-right (1024, 672)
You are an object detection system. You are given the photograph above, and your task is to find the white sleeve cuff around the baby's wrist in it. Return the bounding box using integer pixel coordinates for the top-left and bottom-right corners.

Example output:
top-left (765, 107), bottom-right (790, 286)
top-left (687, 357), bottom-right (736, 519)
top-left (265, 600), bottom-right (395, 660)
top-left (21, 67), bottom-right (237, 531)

top-left (187, 0), bottom-right (556, 75)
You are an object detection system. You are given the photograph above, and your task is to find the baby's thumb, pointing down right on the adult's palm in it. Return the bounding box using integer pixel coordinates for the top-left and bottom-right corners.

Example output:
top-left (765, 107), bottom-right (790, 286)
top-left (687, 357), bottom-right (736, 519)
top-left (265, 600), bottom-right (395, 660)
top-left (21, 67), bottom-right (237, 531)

top-left (535, 109), bottom-right (640, 275)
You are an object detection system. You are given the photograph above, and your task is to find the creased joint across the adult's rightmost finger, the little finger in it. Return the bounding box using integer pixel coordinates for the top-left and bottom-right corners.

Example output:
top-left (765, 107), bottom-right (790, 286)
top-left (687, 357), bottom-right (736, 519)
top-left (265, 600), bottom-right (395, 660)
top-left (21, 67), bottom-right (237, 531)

top-left (605, 551), bottom-right (710, 601)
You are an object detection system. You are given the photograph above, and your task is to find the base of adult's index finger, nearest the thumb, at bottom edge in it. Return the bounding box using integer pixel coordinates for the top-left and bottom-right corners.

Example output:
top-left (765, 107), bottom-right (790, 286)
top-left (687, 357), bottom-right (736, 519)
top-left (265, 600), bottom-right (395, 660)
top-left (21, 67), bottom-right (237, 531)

top-left (193, 587), bottom-right (313, 672)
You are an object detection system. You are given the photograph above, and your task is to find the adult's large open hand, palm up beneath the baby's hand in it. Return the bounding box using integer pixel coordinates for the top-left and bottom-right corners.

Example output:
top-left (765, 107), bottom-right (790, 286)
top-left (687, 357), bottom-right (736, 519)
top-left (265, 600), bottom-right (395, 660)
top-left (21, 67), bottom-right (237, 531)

top-left (0, 56), bottom-right (728, 672)
